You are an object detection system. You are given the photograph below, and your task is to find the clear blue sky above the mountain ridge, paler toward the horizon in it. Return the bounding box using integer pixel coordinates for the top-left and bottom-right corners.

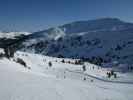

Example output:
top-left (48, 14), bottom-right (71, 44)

top-left (0, 0), bottom-right (133, 31)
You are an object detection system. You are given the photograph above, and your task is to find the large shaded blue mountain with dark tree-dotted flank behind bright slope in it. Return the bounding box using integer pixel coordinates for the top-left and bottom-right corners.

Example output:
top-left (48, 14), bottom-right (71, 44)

top-left (22, 18), bottom-right (133, 63)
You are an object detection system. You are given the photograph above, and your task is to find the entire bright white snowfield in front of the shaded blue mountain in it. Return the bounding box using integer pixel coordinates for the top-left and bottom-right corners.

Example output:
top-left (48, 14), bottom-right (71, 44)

top-left (0, 52), bottom-right (133, 100)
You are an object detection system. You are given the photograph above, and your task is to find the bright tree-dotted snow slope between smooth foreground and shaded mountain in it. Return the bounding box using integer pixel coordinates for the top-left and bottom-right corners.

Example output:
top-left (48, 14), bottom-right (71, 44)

top-left (15, 52), bottom-right (133, 83)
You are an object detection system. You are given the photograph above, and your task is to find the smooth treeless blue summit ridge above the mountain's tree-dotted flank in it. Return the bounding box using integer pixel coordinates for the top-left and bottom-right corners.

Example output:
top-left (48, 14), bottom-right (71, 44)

top-left (59, 18), bottom-right (128, 34)
